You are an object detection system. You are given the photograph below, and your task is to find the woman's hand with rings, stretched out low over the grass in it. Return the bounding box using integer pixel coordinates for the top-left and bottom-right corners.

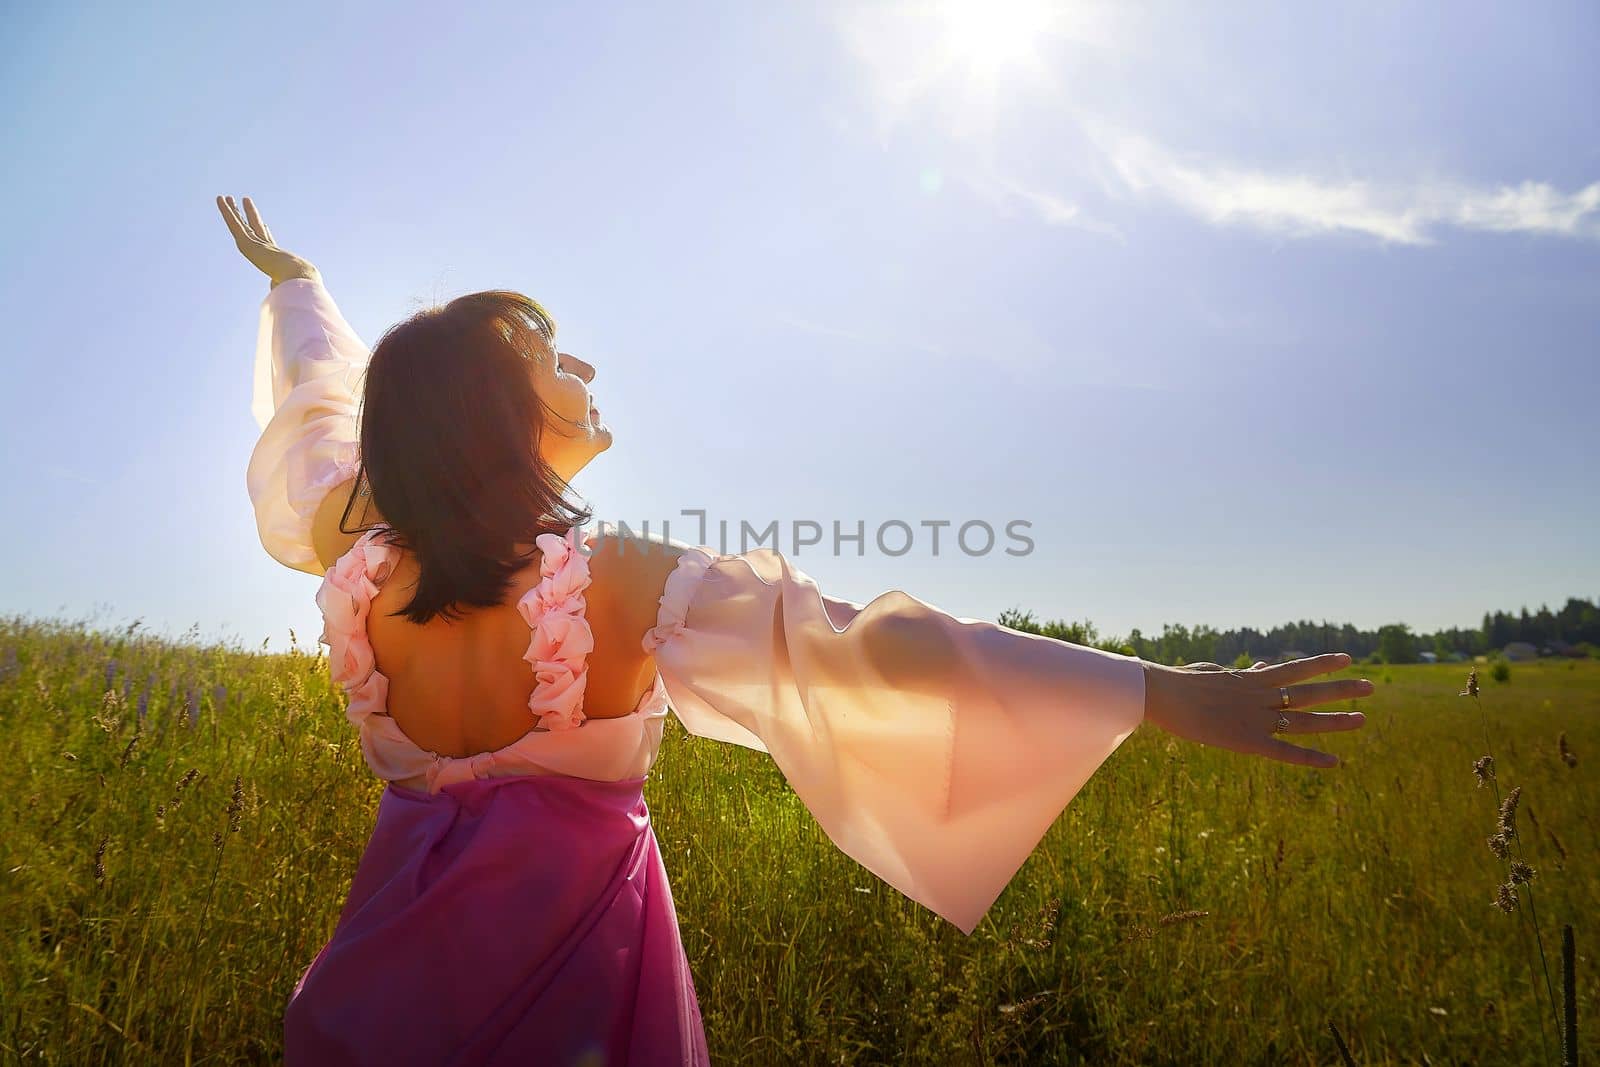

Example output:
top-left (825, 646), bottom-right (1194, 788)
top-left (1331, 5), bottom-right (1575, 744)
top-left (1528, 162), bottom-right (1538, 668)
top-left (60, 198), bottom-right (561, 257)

top-left (1144, 653), bottom-right (1373, 766)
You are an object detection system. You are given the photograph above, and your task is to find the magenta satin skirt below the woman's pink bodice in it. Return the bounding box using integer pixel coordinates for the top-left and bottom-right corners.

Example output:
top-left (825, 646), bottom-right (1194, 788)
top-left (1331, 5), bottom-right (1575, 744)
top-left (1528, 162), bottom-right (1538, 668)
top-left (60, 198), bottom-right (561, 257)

top-left (283, 776), bottom-right (709, 1065)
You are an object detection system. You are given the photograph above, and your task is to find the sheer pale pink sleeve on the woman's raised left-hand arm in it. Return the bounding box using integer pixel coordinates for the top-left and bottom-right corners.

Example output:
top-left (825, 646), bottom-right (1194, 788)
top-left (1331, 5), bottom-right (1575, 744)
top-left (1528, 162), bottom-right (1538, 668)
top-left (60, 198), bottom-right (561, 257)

top-left (245, 278), bottom-right (370, 576)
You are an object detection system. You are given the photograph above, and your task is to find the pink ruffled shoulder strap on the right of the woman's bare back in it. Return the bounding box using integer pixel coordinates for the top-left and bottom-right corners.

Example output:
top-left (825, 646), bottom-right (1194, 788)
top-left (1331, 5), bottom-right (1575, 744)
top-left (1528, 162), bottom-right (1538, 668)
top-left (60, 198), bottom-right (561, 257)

top-left (517, 526), bottom-right (595, 731)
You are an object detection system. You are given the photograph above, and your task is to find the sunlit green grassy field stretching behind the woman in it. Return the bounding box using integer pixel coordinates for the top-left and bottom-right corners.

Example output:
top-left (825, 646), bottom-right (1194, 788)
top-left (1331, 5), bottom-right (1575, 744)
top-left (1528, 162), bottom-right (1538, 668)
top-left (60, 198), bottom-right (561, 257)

top-left (0, 617), bottom-right (1600, 1064)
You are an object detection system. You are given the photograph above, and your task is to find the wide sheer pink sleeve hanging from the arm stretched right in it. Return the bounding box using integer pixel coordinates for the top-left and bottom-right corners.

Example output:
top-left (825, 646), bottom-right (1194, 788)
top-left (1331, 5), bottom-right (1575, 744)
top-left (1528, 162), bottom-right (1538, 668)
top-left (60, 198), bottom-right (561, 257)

top-left (645, 549), bottom-right (1144, 934)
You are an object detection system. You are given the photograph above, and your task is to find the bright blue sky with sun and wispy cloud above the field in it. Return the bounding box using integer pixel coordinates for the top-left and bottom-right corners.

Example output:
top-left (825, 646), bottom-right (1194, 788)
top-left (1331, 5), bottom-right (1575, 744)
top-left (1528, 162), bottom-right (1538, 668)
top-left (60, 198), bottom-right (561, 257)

top-left (0, 3), bottom-right (1600, 648)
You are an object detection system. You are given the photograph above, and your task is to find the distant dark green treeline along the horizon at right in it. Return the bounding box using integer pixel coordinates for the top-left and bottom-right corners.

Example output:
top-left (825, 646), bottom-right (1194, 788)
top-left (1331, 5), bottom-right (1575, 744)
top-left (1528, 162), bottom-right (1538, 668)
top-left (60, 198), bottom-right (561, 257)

top-left (998, 597), bottom-right (1600, 665)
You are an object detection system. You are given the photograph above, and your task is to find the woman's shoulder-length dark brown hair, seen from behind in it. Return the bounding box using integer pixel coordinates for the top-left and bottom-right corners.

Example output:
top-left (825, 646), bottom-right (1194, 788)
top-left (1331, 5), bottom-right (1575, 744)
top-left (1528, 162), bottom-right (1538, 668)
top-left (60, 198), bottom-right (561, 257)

top-left (339, 290), bottom-right (592, 625)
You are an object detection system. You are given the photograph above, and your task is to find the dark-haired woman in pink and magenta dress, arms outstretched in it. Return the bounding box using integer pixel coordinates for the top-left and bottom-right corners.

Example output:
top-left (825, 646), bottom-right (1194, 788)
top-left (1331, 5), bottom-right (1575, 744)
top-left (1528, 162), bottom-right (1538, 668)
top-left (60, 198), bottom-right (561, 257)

top-left (218, 197), bottom-right (1371, 1064)
